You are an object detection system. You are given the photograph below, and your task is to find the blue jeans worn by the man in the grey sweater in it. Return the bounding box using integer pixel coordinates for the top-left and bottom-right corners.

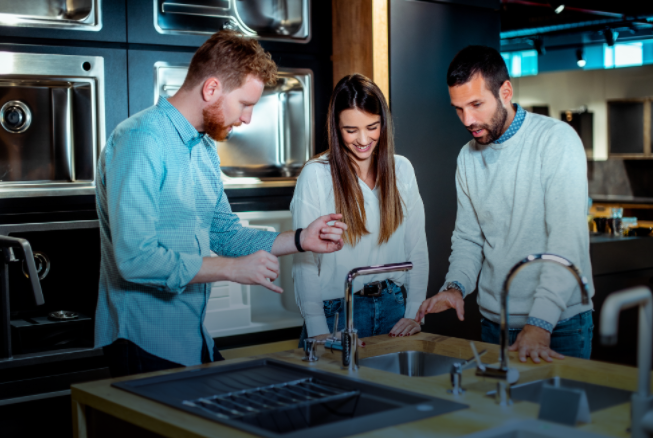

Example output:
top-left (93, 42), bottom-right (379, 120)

top-left (481, 310), bottom-right (594, 359)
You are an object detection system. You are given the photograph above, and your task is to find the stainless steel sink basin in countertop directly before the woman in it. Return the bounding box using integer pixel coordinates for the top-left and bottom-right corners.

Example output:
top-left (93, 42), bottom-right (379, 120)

top-left (359, 351), bottom-right (464, 377)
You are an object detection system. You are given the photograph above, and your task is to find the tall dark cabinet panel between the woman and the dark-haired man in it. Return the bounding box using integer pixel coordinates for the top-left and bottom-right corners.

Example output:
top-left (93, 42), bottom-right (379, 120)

top-left (390, 0), bottom-right (500, 339)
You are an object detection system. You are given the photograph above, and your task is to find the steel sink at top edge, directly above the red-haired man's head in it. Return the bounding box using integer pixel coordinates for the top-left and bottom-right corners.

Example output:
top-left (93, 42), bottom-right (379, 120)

top-left (154, 0), bottom-right (310, 42)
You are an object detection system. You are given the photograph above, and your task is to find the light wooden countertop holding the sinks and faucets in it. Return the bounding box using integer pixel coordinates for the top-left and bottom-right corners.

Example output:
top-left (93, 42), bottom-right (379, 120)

top-left (71, 333), bottom-right (637, 438)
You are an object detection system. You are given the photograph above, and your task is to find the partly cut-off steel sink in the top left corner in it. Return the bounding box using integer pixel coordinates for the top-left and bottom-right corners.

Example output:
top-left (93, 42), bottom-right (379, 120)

top-left (0, 0), bottom-right (102, 31)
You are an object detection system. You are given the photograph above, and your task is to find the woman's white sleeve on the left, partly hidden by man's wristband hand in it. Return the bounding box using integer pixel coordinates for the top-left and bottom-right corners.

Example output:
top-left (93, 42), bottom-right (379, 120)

top-left (290, 164), bottom-right (329, 337)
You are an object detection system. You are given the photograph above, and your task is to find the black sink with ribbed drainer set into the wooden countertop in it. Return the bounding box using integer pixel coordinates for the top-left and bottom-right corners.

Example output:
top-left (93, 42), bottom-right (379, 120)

top-left (113, 359), bottom-right (467, 438)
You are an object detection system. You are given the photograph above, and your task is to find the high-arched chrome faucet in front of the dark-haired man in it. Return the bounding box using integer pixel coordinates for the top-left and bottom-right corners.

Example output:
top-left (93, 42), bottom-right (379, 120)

top-left (476, 254), bottom-right (590, 406)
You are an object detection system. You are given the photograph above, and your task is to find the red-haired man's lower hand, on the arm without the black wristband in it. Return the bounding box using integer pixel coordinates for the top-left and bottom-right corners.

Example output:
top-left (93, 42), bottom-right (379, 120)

top-left (223, 250), bottom-right (283, 294)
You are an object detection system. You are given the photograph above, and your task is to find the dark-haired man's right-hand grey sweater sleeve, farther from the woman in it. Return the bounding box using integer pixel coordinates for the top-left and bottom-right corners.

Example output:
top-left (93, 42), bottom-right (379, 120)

top-left (529, 123), bottom-right (589, 327)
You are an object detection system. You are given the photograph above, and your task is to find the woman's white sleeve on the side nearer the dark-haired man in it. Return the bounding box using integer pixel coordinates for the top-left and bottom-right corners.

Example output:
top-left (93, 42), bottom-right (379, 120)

top-left (404, 160), bottom-right (429, 319)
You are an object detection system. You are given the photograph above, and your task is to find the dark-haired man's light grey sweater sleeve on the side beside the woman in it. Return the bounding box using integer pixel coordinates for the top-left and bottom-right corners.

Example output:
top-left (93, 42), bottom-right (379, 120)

top-left (441, 149), bottom-right (485, 296)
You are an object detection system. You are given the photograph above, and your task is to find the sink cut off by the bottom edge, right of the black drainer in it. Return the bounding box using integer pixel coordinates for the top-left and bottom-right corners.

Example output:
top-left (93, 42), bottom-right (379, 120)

top-left (464, 420), bottom-right (603, 438)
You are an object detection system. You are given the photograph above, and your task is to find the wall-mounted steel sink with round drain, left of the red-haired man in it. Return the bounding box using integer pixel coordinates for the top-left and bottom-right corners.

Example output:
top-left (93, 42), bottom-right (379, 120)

top-left (0, 52), bottom-right (104, 198)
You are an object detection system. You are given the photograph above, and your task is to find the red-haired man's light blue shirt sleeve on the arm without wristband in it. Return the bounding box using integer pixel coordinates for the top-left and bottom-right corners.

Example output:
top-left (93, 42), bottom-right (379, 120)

top-left (105, 129), bottom-right (202, 293)
